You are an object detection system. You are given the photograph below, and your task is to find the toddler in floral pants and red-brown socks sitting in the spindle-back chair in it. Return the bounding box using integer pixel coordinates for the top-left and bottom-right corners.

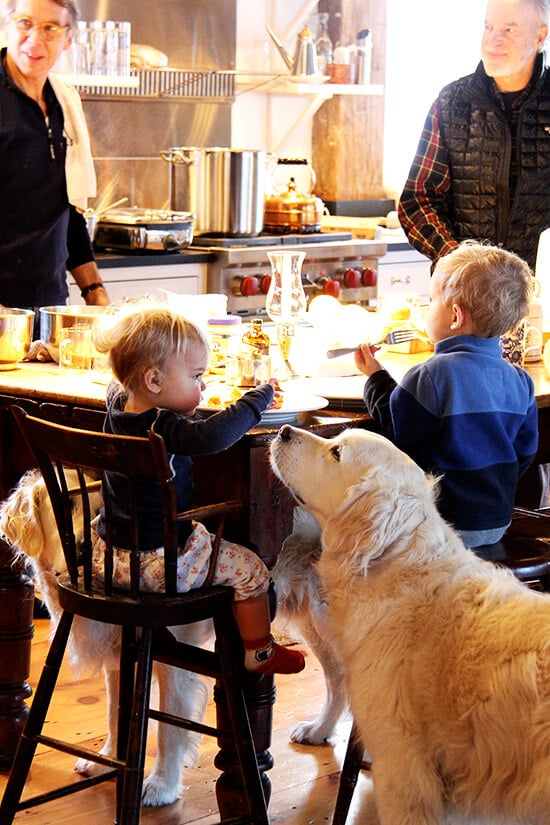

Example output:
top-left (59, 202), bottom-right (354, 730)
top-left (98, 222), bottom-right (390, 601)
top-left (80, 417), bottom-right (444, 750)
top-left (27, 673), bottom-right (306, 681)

top-left (94, 307), bottom-right (305, 673)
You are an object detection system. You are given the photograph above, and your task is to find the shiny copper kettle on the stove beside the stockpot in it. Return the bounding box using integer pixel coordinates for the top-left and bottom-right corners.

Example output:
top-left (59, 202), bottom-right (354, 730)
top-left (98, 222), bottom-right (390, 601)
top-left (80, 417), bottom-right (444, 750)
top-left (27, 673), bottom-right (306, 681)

top-left (264, 178), bottom-right (325, 234)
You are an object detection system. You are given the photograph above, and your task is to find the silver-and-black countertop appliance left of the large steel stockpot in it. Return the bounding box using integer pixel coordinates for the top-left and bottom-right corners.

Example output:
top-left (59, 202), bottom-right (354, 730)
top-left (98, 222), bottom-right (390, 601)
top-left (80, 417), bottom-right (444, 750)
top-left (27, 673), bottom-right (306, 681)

top-left (94, 207), bottom-right (194, 252)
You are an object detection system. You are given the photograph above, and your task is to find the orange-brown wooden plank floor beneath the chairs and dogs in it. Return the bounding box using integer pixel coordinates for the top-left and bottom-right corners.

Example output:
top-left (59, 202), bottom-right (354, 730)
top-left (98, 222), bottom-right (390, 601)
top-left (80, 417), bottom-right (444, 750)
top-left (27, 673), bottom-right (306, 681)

top-left (0, 619), bottom-right (377, 825)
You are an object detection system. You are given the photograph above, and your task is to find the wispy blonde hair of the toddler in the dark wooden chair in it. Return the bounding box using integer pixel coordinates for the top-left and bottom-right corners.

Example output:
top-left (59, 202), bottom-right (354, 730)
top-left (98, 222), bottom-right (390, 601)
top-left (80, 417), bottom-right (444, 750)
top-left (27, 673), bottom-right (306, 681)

top-left (94, 307), bottom-right (210, 389)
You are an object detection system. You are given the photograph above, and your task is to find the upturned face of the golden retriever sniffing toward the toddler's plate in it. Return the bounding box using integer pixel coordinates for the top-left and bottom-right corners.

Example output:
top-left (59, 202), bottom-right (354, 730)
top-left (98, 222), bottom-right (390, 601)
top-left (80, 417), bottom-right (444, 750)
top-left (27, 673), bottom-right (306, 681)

top-left (271, 426), bottom-right (426, 525)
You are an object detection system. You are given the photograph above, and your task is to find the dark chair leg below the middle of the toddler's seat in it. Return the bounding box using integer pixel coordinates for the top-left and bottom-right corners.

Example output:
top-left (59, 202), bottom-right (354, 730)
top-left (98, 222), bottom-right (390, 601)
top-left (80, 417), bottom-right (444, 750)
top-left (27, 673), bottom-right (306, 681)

top-left (119, 628), bottom-right (153, 825)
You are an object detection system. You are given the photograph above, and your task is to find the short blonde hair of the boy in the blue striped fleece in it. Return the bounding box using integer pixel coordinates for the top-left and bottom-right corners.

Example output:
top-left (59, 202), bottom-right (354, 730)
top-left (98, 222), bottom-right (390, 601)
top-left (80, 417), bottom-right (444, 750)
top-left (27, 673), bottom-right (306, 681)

top-left (434, 241), bottom-right (533, 338)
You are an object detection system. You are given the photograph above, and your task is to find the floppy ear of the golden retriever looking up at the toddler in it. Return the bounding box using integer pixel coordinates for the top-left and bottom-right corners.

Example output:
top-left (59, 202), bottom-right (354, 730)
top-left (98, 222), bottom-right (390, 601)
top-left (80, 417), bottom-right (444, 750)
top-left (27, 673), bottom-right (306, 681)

top-left (323, 472), bottom-right (432, 575)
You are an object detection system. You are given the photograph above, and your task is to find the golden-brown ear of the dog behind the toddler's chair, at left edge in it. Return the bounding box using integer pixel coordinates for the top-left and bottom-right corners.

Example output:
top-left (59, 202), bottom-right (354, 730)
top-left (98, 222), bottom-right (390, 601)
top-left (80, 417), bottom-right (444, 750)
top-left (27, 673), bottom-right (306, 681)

top-left (0, 470), bottom-right (49, 558)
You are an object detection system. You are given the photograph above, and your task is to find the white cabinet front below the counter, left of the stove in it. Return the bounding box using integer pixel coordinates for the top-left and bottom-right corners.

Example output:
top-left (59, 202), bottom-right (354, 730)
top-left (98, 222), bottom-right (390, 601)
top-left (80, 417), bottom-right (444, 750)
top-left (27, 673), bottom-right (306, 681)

top-left (69, 261), bottom-right (206, 304)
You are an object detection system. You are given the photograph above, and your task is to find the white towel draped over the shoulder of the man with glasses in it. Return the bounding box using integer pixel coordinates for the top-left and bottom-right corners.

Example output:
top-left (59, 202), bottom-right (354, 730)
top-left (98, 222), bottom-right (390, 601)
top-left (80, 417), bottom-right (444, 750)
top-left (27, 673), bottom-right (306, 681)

top-left (48, 74), bottom-right (97, 212)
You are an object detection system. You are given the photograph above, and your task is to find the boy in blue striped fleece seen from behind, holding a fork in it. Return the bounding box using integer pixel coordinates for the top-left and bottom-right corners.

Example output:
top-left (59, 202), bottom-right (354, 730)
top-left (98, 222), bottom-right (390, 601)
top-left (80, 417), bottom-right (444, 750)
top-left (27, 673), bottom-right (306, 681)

top-left (355, 242), bottom-right (538, 548)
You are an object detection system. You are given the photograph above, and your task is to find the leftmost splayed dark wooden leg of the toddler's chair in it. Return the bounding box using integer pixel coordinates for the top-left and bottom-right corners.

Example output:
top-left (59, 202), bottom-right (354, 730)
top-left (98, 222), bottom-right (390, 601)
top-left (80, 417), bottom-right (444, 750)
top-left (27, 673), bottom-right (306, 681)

top-left (0, 611), bottom-right (73, 825)
